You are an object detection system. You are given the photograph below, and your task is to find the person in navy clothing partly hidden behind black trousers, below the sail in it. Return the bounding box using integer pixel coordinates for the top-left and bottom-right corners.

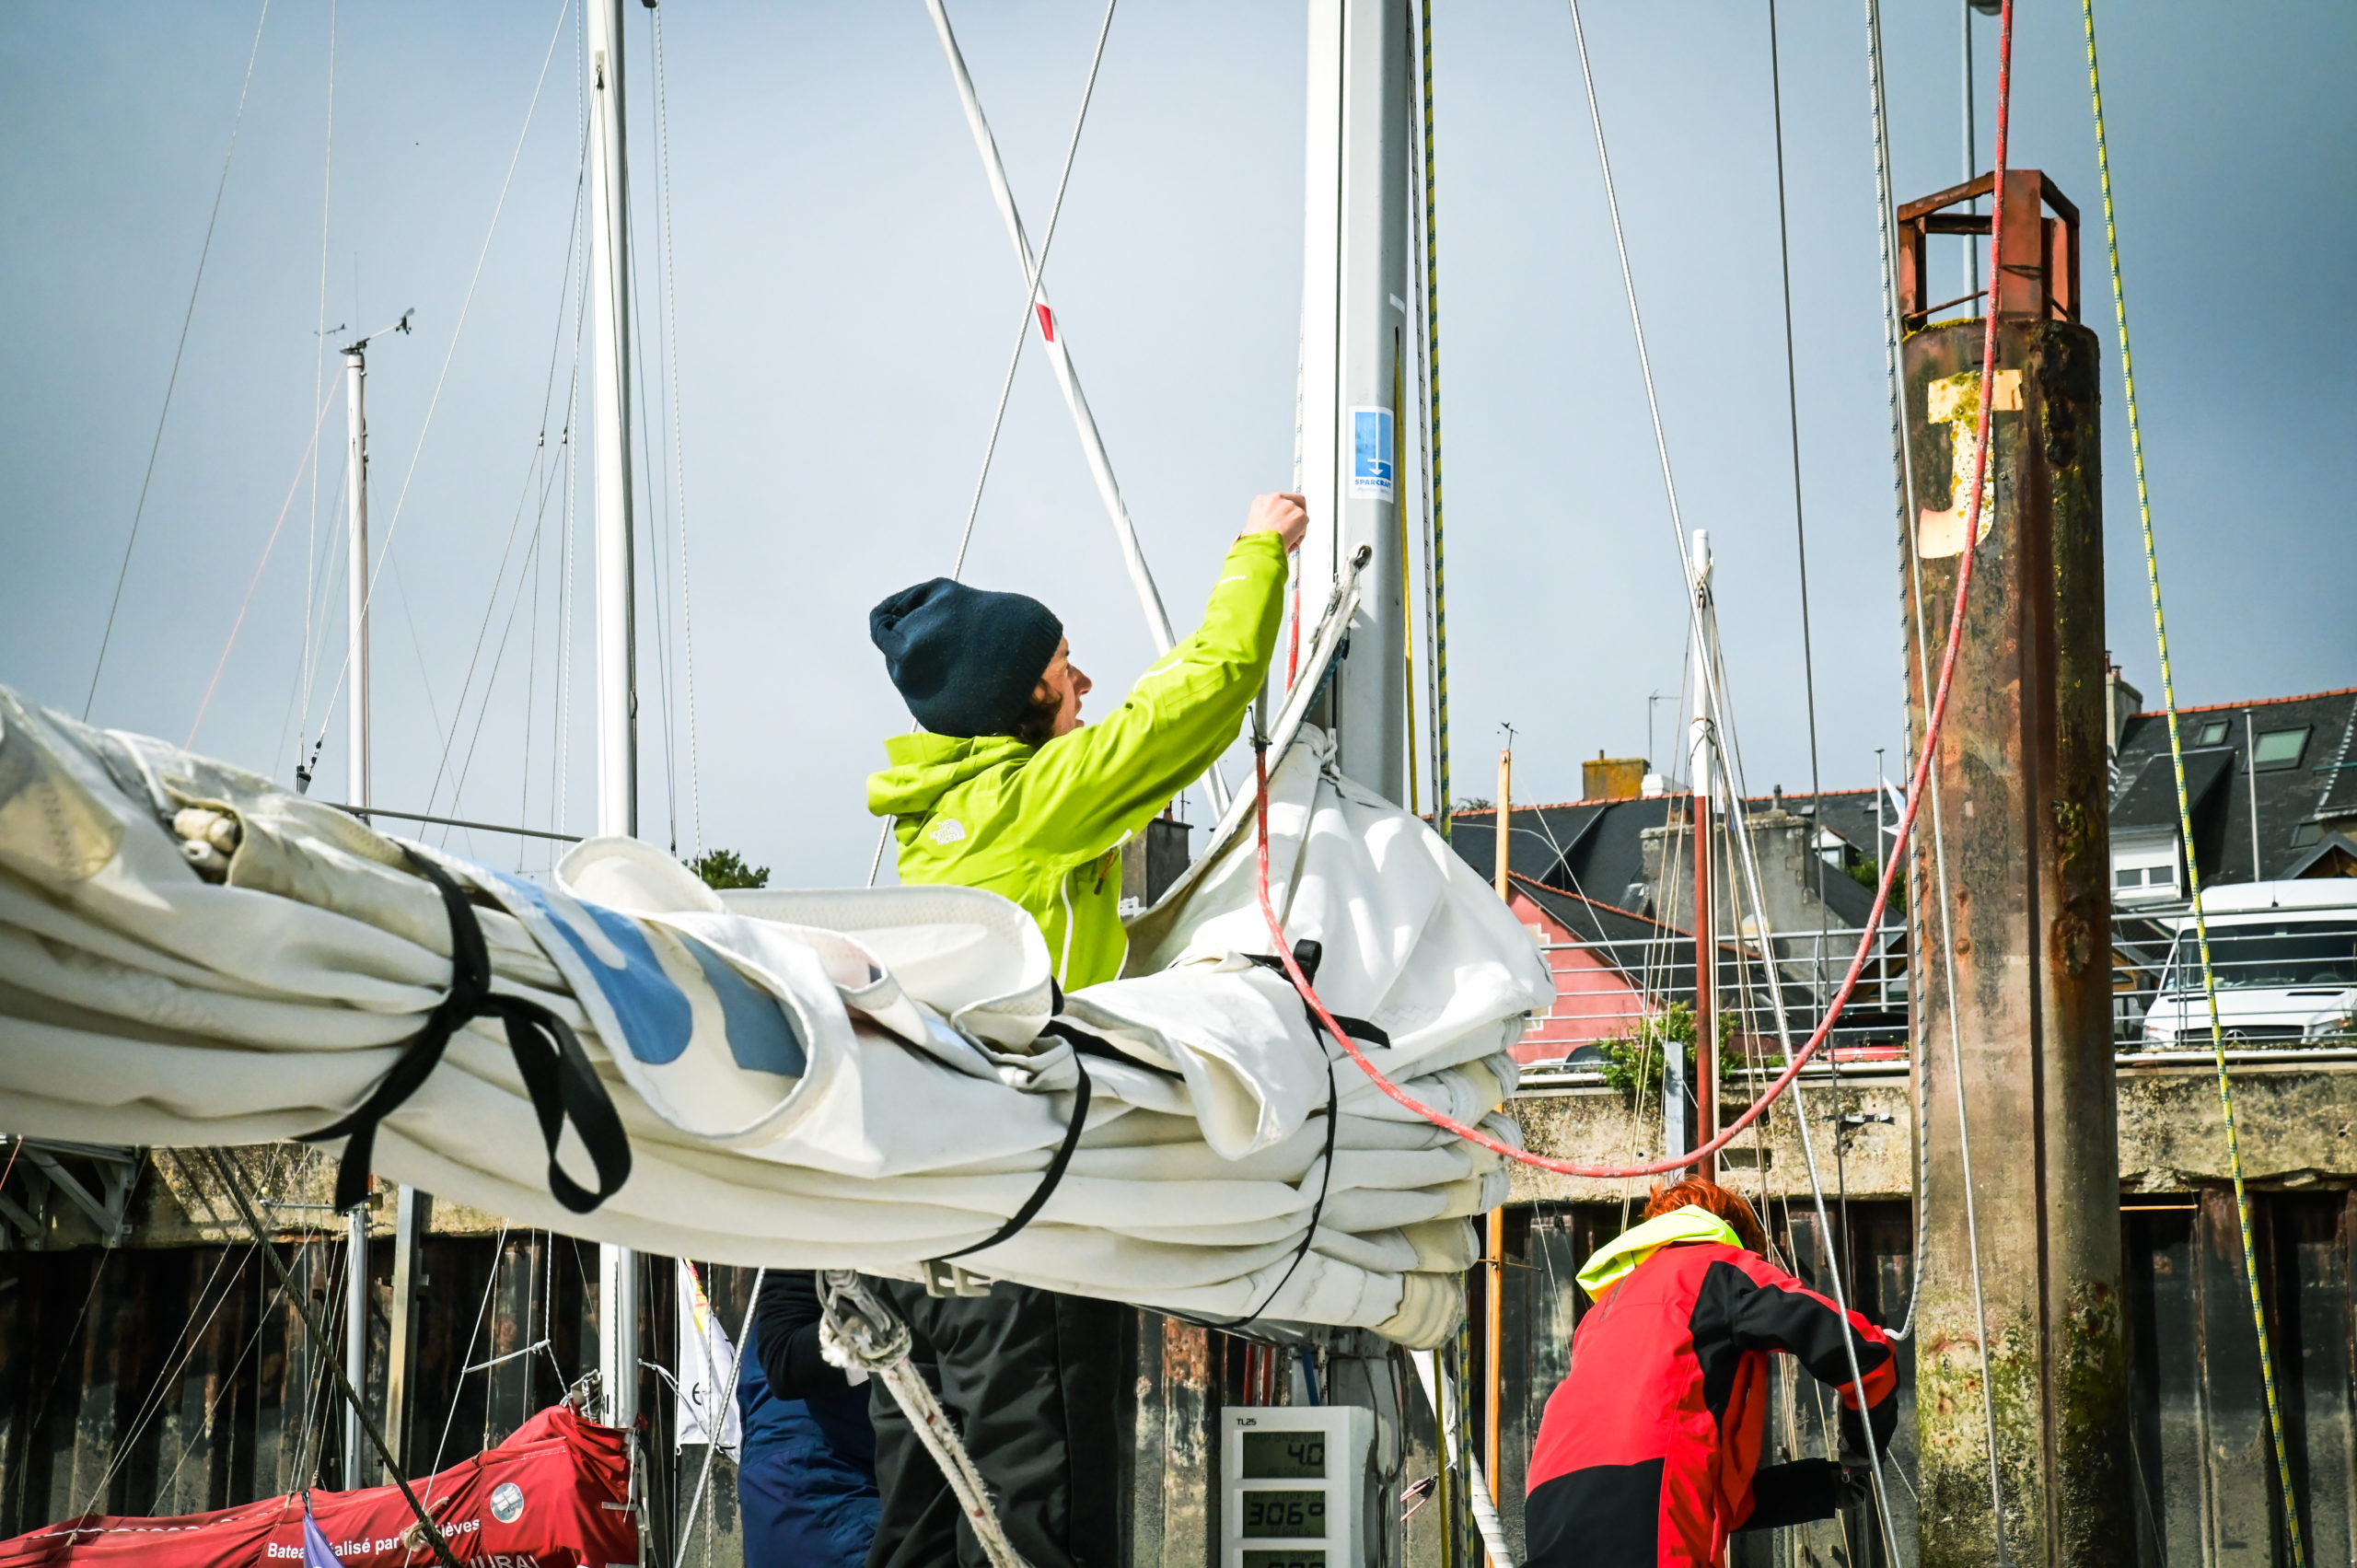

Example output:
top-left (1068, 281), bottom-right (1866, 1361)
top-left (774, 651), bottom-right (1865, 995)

top-left (737, 1269), bottom-right (881, 1568)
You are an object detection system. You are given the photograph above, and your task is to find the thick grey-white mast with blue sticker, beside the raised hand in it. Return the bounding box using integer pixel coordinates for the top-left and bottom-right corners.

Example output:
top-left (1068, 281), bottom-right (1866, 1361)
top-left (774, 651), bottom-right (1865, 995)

top-left (1301, 0), bottom-right (1419, 802)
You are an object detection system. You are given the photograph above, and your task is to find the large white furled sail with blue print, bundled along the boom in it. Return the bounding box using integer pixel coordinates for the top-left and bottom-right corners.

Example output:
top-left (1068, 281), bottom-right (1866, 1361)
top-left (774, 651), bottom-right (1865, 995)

top-left (0, 689), bottom-right (1553, 1344)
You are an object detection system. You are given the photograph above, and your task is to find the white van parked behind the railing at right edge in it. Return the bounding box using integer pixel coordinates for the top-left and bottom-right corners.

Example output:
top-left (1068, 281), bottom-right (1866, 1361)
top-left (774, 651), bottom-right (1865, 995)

top-left (2145, 877), bottom-right (2357, 1050)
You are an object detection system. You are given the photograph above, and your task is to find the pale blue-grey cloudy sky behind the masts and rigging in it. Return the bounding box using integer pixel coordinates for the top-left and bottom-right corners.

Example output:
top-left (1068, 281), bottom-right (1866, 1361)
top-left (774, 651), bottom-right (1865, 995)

top-left (0, 0), bottom-right (2357, 884)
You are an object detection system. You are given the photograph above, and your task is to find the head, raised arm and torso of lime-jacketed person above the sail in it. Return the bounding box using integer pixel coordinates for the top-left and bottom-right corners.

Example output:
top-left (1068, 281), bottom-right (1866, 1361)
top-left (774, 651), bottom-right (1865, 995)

top-left (867, 495), bottom-right (1308, 991)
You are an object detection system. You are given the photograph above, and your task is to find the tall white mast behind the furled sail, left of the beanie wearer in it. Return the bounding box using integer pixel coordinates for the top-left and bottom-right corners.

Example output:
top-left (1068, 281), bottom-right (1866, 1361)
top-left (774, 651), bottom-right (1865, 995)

top-left (589, 0), bottom-right (639, 1429)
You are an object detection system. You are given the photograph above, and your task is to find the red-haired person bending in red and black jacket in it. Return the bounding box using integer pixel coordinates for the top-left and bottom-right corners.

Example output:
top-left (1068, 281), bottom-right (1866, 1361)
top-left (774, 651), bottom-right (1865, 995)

top-left (1523, 1181), bottom-right (1898, 1568)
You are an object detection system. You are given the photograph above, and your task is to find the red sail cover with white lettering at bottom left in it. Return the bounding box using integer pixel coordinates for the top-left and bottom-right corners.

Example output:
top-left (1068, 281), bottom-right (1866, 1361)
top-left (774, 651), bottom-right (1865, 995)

top-left (0, 1405), bottom-right (639, 1568)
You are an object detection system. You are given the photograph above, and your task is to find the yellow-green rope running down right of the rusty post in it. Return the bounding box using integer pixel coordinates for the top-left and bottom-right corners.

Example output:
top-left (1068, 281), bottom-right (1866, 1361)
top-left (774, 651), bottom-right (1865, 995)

top-left (2084, 0), bottom-right (2307, 1568)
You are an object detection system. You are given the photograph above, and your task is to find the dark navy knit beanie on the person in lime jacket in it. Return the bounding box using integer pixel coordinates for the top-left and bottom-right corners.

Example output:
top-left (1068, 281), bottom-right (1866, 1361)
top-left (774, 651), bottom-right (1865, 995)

top-left (867, 577), bottom-right (1063, 736)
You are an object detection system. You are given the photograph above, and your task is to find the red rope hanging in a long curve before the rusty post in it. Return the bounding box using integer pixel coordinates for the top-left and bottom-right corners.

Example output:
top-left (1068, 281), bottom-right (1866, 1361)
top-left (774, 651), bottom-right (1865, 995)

top-left (1251, 0), bottom-right (2013, 1179)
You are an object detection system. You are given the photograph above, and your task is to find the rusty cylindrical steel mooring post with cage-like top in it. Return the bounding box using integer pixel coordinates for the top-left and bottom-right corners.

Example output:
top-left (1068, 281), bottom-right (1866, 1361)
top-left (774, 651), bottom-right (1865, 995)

top-left (1898, 169), bottom-right (2135, 1568)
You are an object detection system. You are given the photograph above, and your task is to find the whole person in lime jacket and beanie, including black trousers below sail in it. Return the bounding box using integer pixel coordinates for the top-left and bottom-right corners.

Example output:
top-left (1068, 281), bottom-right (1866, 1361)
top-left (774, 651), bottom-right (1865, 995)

top-left (867, 495), bottom-right (1308, 1568)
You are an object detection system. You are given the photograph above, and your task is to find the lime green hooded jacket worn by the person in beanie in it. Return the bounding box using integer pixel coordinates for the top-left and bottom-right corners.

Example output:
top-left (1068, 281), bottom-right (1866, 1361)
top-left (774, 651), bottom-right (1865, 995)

top-left (867, 533), bottom-right (1284, 991)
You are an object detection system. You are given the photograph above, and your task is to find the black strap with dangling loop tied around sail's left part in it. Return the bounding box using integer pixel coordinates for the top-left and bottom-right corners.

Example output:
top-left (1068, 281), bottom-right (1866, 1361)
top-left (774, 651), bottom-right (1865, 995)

top-left (299, 844), bottom-right (630, 1214)
